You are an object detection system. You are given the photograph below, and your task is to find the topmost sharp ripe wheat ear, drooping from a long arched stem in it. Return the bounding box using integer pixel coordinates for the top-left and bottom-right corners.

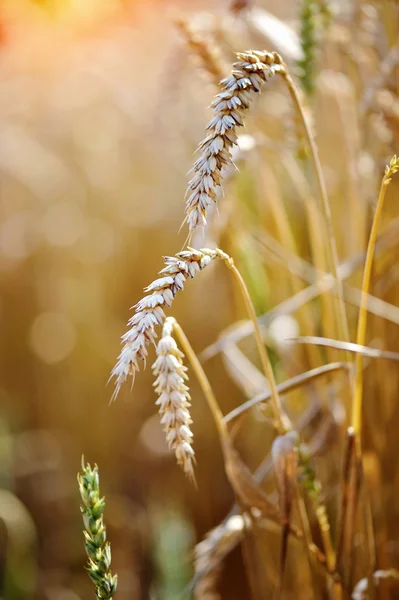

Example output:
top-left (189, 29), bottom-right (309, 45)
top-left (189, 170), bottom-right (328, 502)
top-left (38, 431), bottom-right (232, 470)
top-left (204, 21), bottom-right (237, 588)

top-left (185, 50), bottom-right (285, 232)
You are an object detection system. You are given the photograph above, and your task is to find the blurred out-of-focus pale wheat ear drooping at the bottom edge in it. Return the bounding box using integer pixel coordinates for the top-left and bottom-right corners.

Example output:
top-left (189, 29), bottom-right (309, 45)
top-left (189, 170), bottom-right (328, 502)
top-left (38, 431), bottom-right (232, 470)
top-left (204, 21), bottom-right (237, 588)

top-left (194, 515), bottom-right (251, 600)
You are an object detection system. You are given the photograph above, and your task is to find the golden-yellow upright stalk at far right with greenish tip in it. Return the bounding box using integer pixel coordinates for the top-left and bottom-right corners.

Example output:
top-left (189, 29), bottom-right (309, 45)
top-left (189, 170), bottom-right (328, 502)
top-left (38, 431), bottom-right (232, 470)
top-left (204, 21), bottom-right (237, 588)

top-left (351, 155), bottom-right (399, 440)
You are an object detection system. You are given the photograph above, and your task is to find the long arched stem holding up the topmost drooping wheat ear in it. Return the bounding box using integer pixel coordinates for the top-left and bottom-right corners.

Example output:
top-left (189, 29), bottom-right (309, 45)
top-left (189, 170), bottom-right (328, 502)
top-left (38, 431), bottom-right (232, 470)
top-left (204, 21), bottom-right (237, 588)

top-left (279, 66), bottom-right (352, 372)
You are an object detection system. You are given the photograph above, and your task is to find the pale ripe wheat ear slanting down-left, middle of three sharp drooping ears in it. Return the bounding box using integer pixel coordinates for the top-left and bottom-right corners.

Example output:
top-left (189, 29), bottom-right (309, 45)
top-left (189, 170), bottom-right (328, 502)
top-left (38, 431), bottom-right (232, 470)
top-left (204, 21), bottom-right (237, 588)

top-left (111, 248), bottom-right (225, 400)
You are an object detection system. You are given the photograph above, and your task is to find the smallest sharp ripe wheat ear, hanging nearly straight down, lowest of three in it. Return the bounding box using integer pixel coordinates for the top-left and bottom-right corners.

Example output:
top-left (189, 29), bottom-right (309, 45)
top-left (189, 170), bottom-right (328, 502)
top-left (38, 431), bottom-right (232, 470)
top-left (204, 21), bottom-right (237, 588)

top-left (152, 317), bottom-right (195, 482)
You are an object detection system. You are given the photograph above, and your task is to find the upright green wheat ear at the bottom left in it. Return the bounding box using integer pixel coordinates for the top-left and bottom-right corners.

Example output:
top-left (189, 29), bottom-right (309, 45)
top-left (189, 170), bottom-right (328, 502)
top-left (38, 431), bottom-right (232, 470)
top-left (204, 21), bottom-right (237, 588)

top-left (78, 456), bottom-right (118, 600)
